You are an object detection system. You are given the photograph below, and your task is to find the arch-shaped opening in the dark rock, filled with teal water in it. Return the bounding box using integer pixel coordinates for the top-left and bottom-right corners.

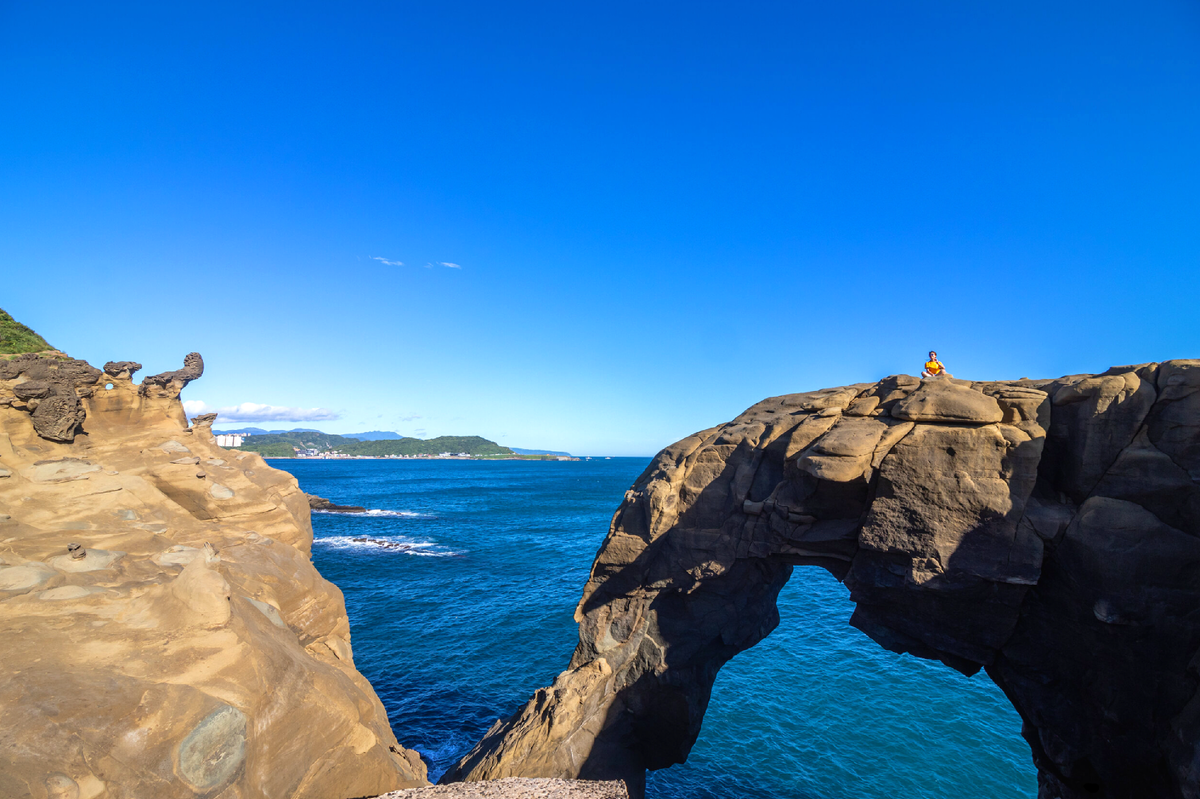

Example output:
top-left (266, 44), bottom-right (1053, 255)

top-left (646, 565), bottom-right (1037, 799)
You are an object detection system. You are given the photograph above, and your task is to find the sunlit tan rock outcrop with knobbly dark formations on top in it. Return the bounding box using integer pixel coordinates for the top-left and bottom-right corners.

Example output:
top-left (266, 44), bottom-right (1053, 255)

top-left (0, 354), bottom-right (427, 799)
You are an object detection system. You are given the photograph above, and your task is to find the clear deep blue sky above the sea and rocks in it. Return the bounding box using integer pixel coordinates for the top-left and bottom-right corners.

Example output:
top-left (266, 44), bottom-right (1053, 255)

top-left (0, 0), bottom-right (1200, 455)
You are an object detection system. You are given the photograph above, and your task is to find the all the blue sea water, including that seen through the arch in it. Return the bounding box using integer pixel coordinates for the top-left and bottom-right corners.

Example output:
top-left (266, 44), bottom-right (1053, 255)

top-left (271, 458), bottom-right (1037, 799)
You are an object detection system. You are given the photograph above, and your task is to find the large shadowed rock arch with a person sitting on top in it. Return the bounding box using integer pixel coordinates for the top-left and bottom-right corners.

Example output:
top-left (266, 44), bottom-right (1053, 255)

top-left (444, 361), bottom-right (1200, 799)
